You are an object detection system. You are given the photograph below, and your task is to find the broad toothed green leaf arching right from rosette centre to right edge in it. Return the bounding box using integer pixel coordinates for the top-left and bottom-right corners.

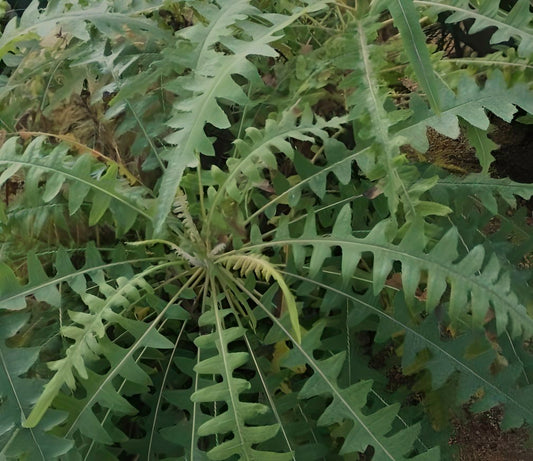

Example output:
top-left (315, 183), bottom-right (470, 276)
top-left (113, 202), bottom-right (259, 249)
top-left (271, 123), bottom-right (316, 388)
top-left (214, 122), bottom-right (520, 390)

top-left (264, 204), bottom-right (533, 337)
